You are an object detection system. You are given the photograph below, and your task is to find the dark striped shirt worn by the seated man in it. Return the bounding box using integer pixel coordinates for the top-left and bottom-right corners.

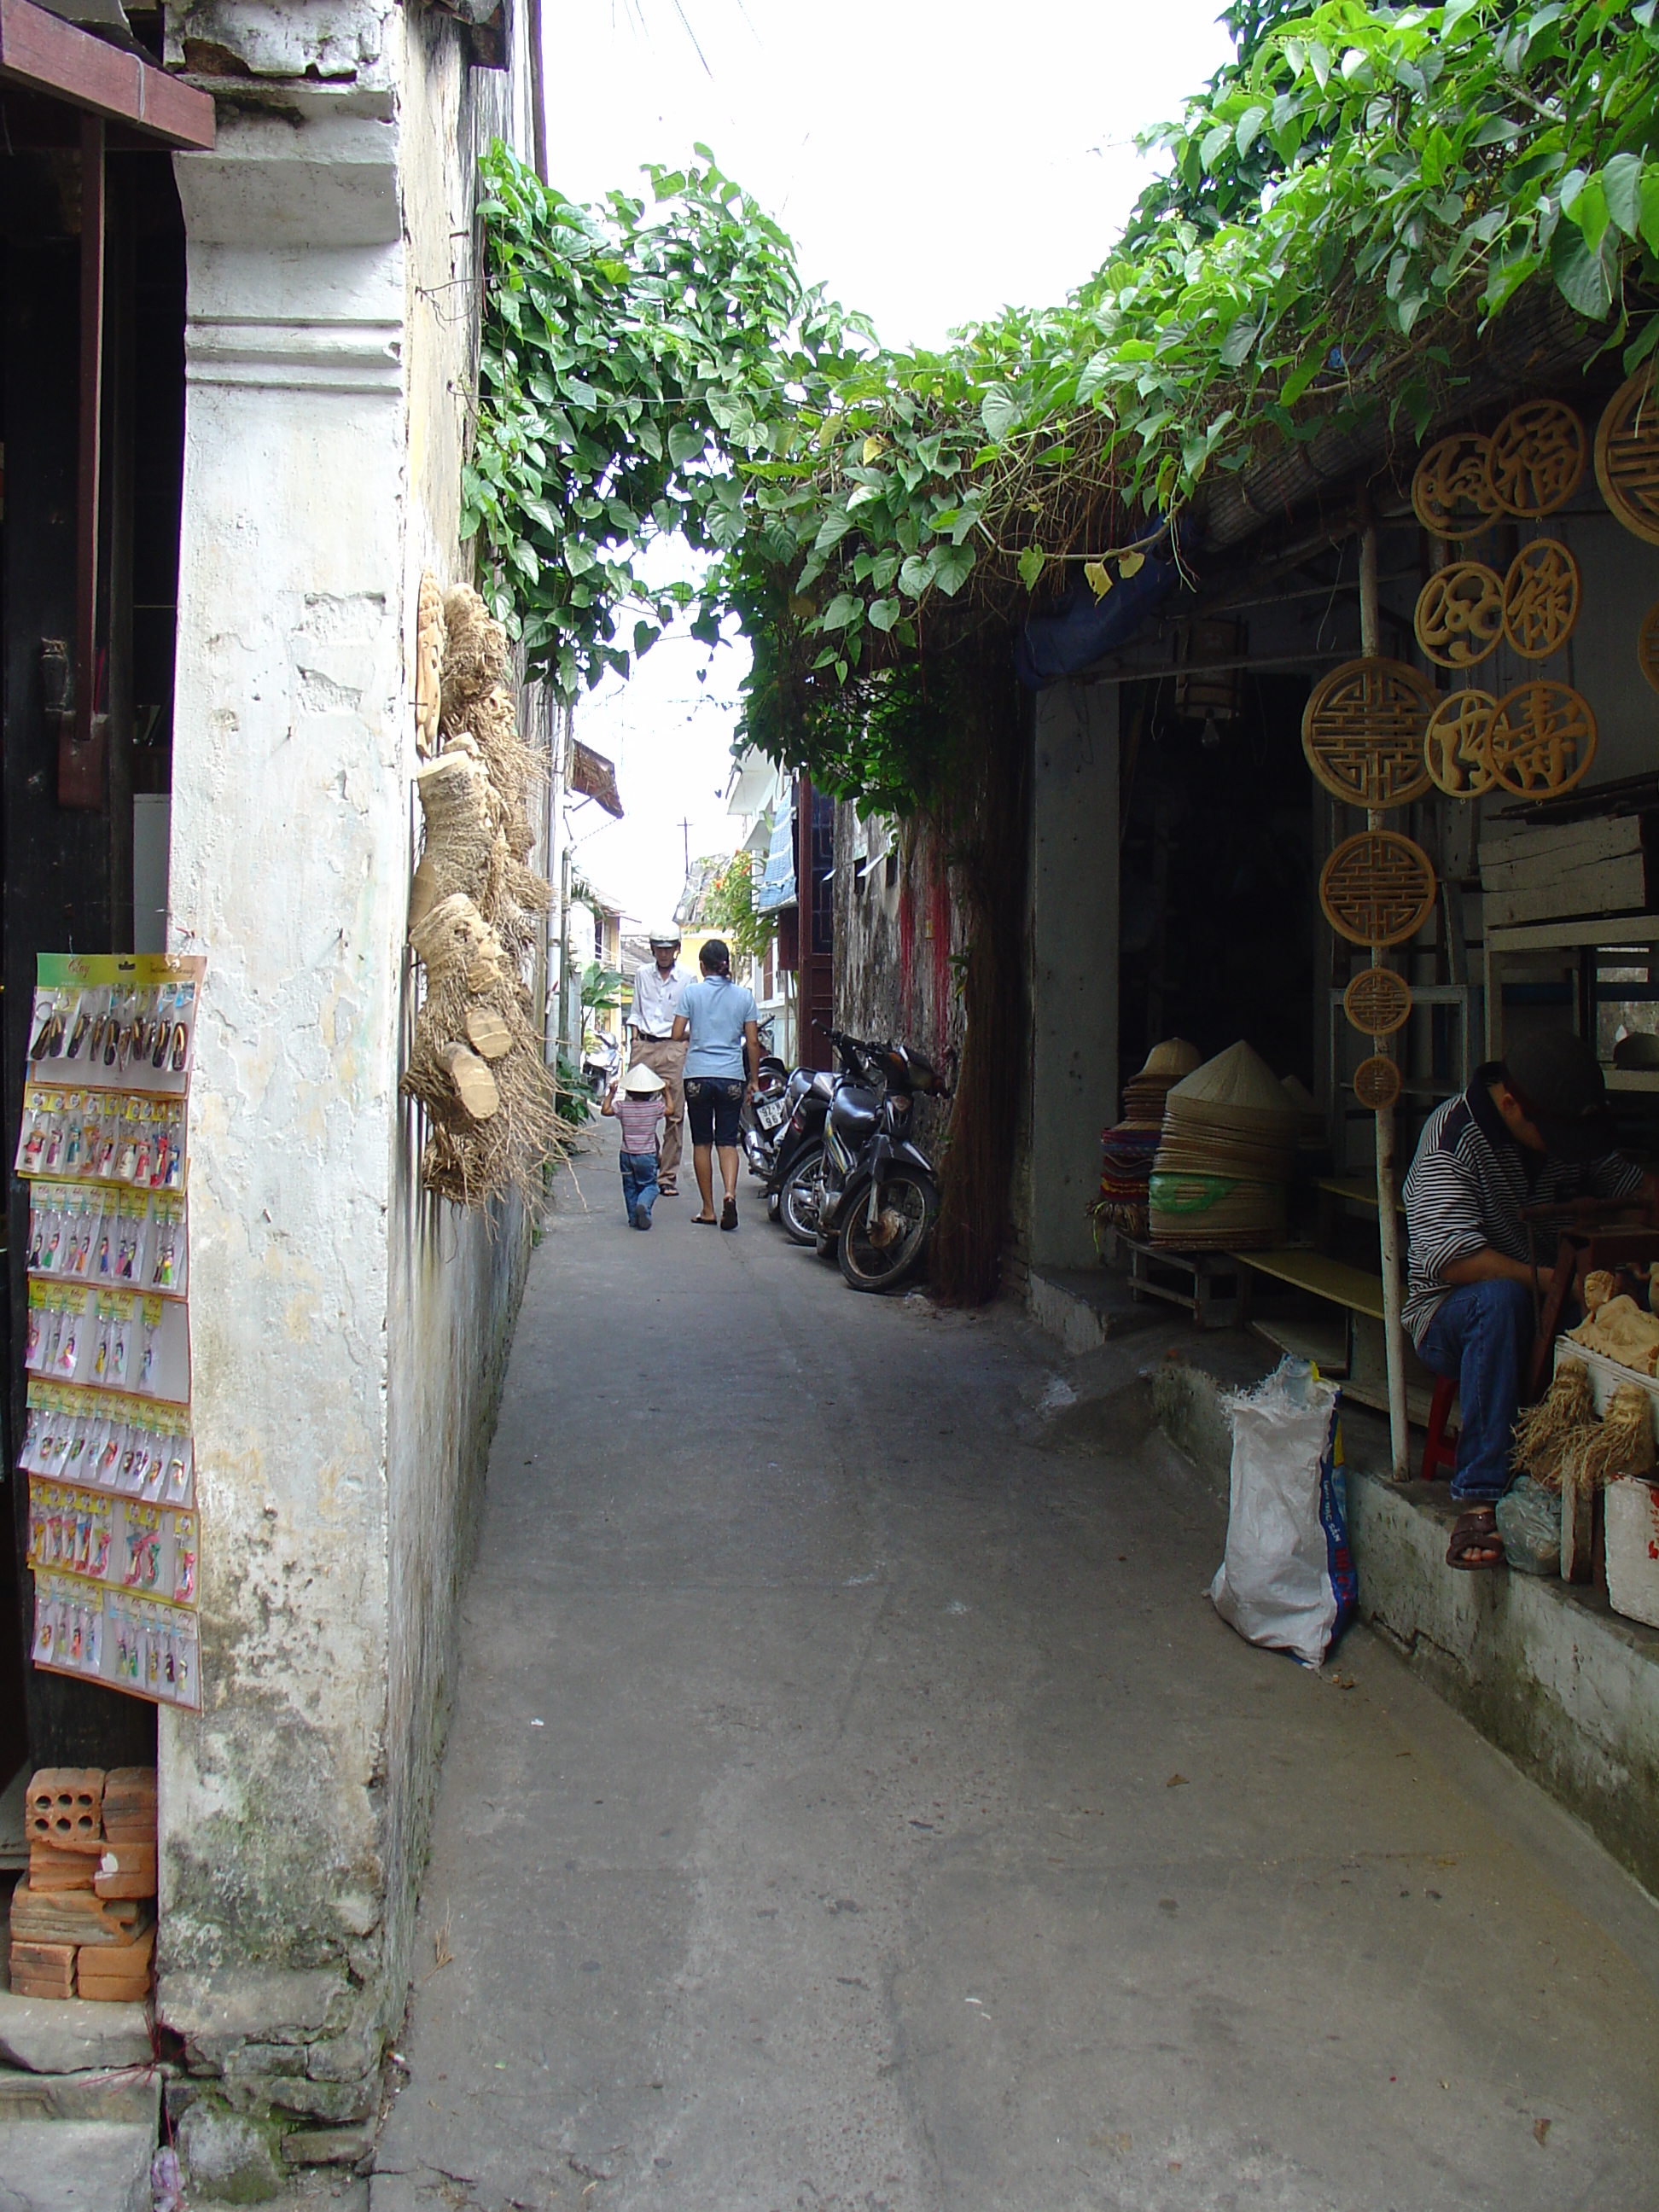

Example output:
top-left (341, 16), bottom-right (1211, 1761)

top-left (1400, 1062), bottom-right (1641, 1345)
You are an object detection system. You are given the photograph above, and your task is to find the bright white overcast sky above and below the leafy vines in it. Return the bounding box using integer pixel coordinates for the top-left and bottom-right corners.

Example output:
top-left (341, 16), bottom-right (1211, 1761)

top-left (542, 0), bottom-right (1228, 923)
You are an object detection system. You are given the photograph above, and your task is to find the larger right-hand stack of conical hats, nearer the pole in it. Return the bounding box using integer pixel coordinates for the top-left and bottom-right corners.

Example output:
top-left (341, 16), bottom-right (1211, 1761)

top-left (1148, 1042), bottom-right (1299, 1252)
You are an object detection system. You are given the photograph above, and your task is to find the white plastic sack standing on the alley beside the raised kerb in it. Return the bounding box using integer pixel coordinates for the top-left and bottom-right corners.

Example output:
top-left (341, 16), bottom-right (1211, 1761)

top-left (1210, 1358), bottom-right (1356, 1666)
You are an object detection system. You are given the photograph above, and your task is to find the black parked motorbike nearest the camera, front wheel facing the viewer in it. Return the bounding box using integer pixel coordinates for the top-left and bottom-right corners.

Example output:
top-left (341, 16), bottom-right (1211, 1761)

top-left (816, 1033), bottom-right (945, 1289)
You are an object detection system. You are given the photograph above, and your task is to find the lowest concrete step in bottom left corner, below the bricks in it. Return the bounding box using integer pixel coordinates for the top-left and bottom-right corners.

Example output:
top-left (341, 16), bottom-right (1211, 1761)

top-left (0, 2061), bottom-right (161, 2212)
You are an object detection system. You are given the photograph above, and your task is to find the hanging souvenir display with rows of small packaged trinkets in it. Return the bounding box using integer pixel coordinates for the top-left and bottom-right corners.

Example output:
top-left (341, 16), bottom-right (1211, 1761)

top-left (15, 953), bottom-right (206, 1710)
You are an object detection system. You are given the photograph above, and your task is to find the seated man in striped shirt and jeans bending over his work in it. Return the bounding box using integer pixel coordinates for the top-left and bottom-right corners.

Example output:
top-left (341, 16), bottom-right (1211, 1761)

top-left (1402, 1028), bottom-right (1656, 1569)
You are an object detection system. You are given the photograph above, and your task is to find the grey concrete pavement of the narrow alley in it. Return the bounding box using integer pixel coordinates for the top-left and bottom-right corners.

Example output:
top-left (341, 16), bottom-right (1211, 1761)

top-left (370, 1137), bottom-right (1659, 2212)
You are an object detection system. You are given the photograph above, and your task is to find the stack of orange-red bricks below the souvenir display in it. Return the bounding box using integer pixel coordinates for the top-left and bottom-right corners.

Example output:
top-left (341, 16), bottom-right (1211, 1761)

top-left (11, 1767), bottom-right (154, 2004)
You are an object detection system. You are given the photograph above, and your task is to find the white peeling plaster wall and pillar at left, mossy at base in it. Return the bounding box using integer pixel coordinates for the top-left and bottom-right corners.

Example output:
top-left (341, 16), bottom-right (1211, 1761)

top-left (157, 0), bottom-right (539, 2122)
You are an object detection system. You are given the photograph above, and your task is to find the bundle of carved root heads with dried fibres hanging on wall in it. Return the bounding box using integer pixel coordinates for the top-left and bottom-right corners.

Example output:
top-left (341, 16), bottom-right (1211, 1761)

top-left (400, 578), bottom-right (567, 1208)
